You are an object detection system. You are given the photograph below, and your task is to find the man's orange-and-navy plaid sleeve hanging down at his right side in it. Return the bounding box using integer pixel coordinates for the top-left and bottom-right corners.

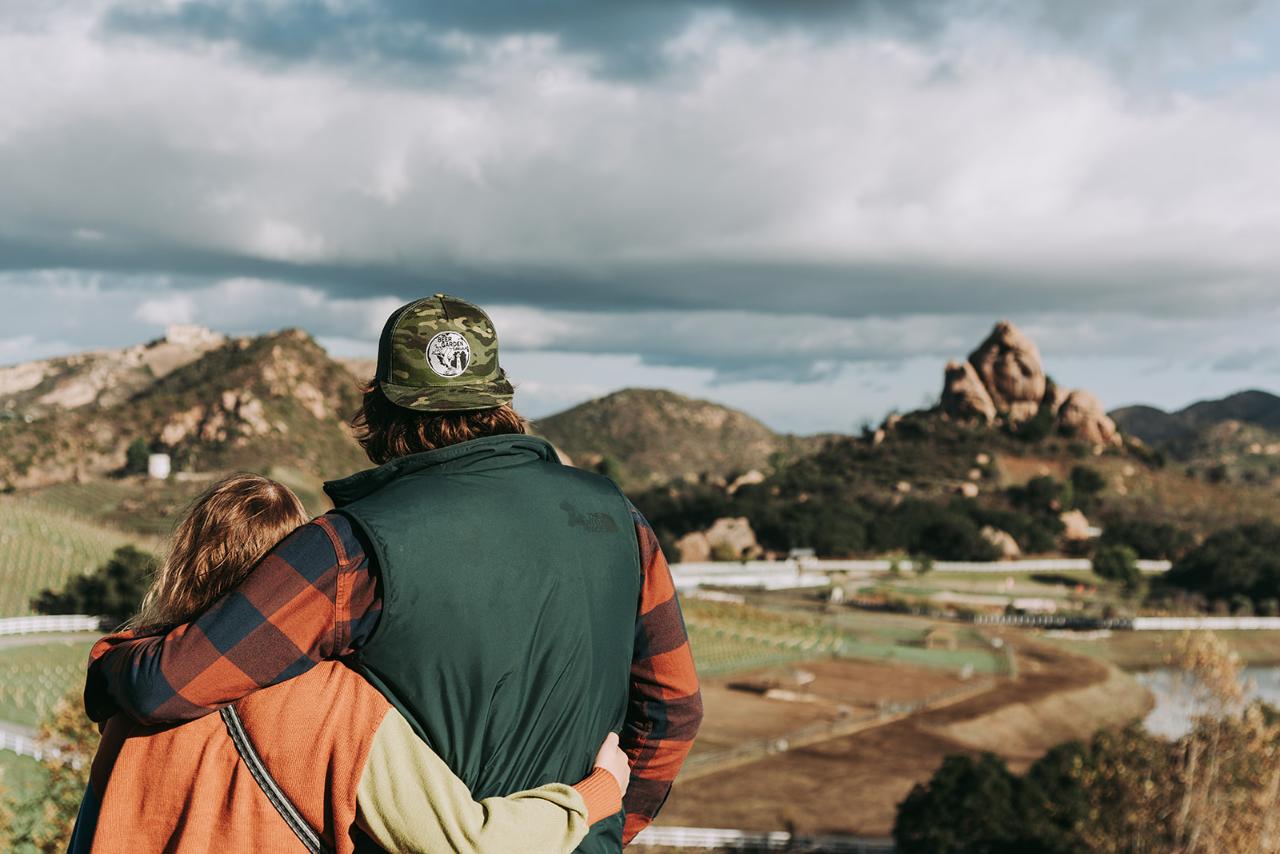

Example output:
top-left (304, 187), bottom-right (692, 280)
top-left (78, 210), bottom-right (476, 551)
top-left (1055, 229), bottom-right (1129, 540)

top-left (622, 507), bottom-right (703, 842)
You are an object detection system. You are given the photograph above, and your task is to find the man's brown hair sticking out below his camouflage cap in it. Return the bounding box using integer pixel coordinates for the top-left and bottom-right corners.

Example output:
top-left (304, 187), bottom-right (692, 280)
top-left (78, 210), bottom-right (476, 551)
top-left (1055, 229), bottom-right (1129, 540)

top-left (351, 380), bottom-right (526, 465)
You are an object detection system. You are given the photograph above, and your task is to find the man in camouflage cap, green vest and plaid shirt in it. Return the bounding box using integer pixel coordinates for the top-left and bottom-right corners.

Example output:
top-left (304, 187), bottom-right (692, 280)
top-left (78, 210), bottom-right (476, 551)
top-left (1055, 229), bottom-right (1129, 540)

top-left (86, 294), bottom-right (701, 851)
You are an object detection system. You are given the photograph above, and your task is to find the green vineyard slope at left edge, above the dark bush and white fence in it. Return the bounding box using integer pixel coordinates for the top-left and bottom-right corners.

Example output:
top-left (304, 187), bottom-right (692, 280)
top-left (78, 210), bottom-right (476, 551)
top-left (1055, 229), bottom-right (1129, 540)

top-left (0, 497), bottom-right (154, 617)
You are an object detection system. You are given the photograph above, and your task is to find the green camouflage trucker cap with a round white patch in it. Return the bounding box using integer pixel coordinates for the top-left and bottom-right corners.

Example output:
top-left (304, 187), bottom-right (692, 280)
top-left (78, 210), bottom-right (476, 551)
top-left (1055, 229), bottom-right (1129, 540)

top-left (376, 293), bottom-right (515, 412)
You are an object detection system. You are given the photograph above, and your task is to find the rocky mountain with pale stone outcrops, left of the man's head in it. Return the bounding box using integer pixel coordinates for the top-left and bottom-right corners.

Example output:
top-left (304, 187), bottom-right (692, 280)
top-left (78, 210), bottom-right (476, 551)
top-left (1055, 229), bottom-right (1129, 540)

top-left (0, 330), bottom-right (367, 488)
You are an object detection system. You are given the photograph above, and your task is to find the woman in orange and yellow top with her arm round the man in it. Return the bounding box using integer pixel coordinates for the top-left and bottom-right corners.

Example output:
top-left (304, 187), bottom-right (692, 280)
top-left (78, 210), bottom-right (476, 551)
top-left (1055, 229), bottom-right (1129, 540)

top-left (70, 475), bottom-right (628, 854)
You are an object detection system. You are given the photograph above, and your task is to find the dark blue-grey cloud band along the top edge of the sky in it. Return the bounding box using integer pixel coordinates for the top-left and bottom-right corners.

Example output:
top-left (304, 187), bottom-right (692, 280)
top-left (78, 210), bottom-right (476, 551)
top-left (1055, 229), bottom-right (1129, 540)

top-left (104, 0), bottom-right (947, 79)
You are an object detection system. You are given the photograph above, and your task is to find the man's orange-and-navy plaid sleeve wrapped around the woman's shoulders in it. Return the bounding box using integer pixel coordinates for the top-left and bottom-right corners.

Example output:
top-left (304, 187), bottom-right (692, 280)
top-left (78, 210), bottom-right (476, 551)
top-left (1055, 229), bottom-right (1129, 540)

top-left (84, 513), bottom-right (381, 723)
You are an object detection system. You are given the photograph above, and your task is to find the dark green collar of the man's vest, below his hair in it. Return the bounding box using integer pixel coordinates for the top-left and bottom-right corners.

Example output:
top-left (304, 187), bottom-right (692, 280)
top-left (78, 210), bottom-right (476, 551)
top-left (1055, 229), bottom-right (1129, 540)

top-left (324, 434), bottom-right (559, 507)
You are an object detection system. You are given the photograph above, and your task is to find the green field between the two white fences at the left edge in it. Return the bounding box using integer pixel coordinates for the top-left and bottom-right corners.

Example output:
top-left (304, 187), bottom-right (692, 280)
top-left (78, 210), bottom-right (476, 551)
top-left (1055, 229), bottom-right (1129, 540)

top-left (0, 640), bottom-right (92, 726)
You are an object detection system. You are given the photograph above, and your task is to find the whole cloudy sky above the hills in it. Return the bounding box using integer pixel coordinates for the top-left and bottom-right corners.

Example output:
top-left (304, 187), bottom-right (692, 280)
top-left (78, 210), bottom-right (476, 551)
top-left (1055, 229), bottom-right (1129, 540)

top-left (0, 0), bottom-right (1280, 431)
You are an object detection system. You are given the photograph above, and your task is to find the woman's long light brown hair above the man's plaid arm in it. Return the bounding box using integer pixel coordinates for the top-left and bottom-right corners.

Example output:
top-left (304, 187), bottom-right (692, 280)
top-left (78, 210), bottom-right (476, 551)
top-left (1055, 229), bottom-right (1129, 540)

top-left (129, 474), bottom-right (308, 629)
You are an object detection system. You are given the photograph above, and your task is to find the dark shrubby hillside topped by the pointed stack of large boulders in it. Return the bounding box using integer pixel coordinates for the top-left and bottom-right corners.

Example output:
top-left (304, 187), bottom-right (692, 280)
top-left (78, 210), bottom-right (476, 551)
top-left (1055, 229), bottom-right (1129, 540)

top-left (634, 323), bottom-right (1280, 561)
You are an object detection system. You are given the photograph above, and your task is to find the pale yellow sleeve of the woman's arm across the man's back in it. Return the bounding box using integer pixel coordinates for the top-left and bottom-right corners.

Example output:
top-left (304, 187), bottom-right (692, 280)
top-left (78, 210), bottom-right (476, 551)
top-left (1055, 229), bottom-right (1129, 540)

top-left (356, 708), bottom-right (589, 854)
